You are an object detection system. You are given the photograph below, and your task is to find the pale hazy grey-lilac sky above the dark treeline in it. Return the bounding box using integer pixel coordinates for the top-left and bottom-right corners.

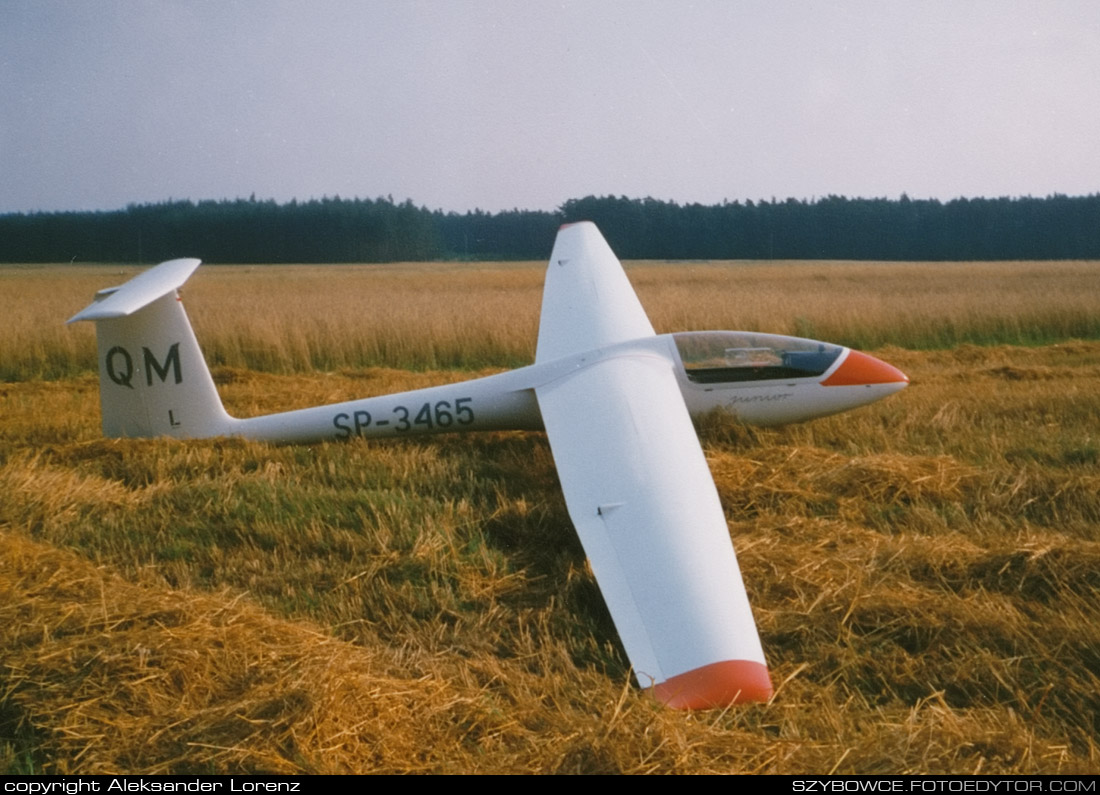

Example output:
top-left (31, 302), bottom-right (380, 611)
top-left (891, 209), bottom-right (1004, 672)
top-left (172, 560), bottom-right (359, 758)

top-left (0, 0), bottom-right (1100, 212)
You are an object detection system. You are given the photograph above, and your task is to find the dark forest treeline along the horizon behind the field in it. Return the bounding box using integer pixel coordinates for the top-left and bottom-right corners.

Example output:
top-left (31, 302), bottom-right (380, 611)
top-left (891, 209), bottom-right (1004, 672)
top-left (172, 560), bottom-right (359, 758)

top-left (0, 194), bottom-right (1100, 263)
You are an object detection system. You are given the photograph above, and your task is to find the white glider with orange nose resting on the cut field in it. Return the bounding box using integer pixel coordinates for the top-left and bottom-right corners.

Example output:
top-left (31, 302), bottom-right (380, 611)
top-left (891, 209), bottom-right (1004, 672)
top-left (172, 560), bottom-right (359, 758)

top-left (68, 222), bottom-right (909, 709)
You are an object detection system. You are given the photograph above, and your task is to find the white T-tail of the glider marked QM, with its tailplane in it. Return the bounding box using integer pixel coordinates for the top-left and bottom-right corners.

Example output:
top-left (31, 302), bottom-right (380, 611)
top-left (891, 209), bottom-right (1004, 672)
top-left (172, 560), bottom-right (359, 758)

top-left (68, 260), bottom-right (233, 439)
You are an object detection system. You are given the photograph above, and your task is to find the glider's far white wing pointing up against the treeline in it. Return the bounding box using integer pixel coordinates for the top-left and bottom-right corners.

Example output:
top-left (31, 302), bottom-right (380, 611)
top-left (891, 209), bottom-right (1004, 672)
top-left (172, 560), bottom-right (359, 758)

top-left (535, 221), bottom-right (653, 362)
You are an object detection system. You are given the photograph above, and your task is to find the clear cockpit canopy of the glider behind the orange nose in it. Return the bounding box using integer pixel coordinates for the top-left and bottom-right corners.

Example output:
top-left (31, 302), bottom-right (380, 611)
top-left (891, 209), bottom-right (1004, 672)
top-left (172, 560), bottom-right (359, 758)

top-left (672, 331), bottom-right (844, 384)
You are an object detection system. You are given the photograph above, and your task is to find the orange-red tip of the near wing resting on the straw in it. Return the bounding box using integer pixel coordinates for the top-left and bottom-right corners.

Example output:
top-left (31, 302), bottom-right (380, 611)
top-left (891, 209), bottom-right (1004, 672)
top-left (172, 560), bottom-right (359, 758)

top-left (653, 660), bottom-right (772, 709)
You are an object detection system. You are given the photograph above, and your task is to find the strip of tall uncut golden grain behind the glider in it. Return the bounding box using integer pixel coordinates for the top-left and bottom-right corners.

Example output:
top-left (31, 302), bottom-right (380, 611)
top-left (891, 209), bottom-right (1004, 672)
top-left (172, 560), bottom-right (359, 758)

top-left (0, 256), bottom-right (1100, 382)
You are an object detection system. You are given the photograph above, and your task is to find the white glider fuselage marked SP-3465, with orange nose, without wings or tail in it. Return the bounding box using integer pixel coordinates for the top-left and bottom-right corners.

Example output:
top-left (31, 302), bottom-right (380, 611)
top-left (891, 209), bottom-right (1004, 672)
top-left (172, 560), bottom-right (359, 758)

top-left (227, 332), bottom-right (909, 442)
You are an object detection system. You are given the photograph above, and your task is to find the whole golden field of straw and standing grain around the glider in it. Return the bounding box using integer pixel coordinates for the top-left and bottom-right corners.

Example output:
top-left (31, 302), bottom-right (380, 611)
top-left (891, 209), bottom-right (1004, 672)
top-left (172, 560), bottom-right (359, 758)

top-left (0, 263), bottom-right (1100, 773)
